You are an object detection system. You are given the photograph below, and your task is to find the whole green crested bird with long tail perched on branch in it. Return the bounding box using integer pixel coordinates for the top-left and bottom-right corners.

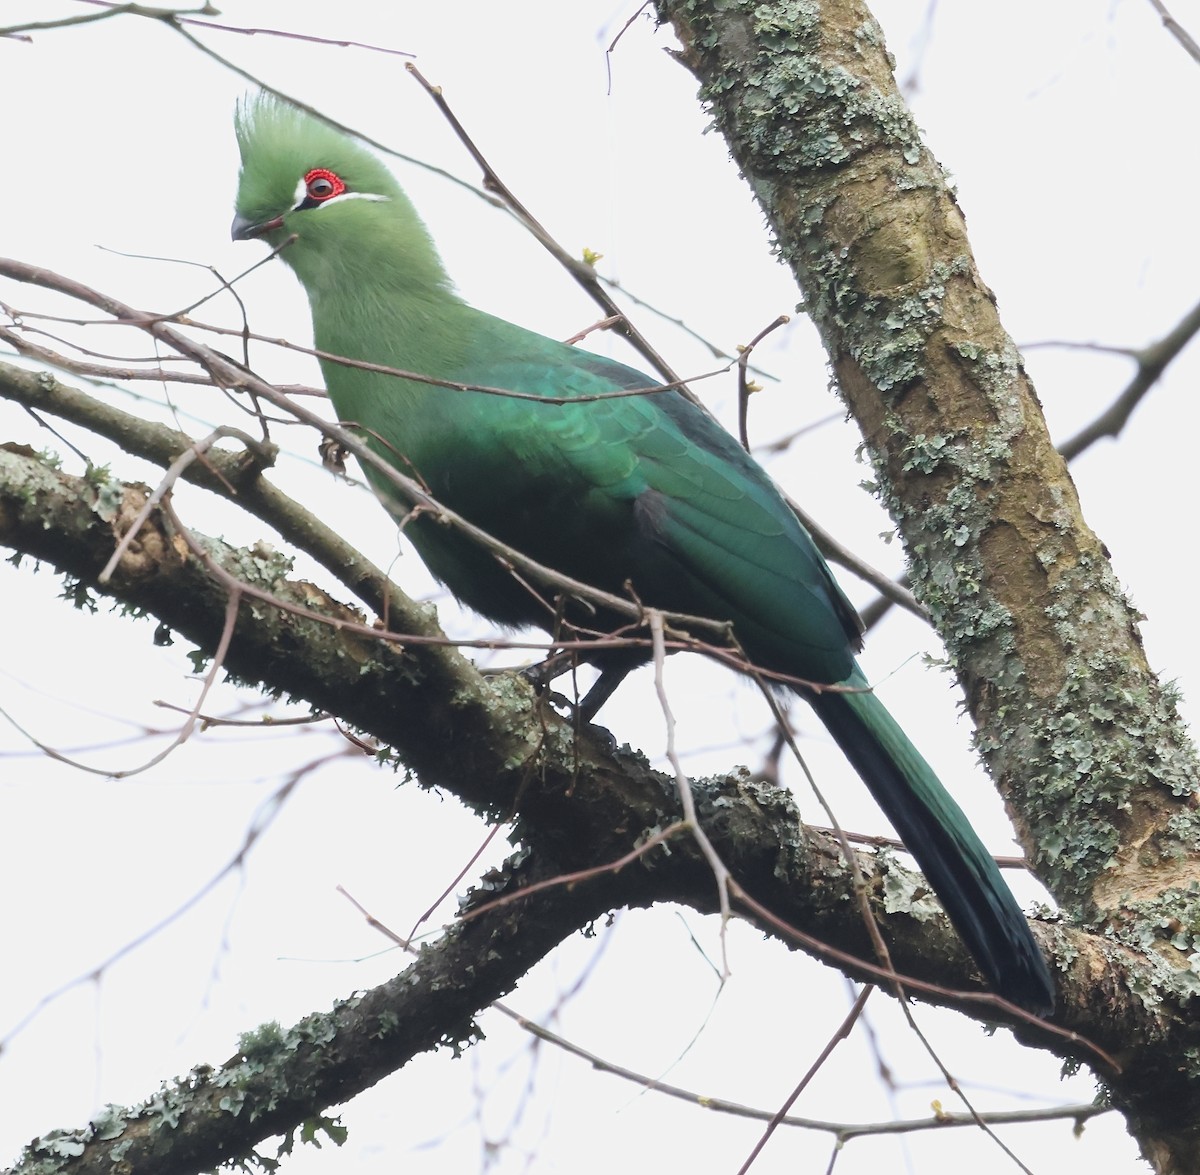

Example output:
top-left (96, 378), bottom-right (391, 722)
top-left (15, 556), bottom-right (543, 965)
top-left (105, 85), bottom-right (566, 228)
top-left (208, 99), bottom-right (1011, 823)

top-left (232, 94), bottom-right (1055, 1015)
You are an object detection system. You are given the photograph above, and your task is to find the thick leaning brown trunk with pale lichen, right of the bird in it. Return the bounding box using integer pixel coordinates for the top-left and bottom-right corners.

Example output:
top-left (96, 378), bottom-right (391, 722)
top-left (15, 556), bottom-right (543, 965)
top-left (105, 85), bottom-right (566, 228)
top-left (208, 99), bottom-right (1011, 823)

top-left (658, 0), bottom-right (1200, 1169)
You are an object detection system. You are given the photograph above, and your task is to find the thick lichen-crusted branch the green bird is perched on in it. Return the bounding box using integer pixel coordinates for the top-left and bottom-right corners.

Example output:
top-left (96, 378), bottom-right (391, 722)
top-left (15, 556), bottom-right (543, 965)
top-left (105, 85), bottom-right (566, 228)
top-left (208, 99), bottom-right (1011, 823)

top-left (0, 445), bottom-right (1041, 988)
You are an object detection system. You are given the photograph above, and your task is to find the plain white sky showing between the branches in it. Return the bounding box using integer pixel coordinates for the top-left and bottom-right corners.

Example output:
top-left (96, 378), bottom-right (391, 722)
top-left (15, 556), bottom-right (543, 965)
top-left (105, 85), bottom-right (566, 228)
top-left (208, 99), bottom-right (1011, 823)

top-left (0, 0), bottom-right (1200, 1175)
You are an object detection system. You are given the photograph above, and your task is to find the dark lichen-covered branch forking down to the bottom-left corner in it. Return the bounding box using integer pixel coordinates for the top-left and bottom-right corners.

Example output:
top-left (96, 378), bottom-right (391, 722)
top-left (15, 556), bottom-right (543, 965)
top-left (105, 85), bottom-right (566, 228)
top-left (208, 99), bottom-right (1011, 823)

top-left (10, 849), bottom-right (606, 1175)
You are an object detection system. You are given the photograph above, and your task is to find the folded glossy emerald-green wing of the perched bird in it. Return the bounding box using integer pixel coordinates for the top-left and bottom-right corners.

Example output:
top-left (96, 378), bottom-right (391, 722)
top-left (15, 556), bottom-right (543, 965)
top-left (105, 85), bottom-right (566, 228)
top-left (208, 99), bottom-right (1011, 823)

top-left (444, 323), bottom-right (858, 682)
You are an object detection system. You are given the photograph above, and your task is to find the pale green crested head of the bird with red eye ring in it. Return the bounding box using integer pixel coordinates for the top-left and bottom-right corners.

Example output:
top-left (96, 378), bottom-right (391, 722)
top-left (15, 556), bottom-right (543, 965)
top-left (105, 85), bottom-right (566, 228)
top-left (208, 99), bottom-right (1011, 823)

top-left (230, 95), bottom-right (440, 294)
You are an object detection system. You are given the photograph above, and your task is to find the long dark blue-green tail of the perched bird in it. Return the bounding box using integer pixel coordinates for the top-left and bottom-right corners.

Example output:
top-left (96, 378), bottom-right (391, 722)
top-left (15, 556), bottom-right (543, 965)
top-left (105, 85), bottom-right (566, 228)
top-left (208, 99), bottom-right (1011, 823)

top-left (809, 672), bottom-right (1054, 1015)
